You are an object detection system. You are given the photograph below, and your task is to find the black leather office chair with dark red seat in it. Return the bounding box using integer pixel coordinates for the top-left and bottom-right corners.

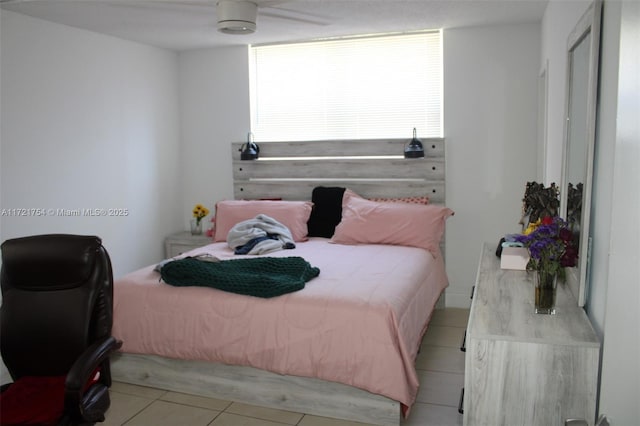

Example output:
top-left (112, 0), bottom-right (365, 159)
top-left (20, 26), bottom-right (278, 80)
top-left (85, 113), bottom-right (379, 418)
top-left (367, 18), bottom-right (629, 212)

top-left (0, 235), bottom-right (122, 425)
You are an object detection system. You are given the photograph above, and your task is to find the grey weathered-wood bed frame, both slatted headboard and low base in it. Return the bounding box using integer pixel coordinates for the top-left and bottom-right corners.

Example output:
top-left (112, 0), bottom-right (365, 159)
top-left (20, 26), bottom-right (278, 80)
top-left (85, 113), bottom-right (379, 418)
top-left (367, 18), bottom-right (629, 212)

top-left (112, 138), bottom-right (445, 426)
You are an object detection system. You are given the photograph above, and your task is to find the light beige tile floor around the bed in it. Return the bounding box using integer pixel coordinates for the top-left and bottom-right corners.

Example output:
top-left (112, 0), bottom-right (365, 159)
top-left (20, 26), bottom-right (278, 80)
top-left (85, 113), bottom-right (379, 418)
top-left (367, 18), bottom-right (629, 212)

top-left (101, 308), bottom-right (469, 426)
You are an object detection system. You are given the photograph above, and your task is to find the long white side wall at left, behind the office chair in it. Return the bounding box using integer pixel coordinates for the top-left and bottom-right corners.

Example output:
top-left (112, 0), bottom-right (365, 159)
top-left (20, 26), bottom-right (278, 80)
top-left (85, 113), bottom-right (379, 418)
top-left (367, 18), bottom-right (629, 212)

top-left (0, 11), bottom-right (181, 276)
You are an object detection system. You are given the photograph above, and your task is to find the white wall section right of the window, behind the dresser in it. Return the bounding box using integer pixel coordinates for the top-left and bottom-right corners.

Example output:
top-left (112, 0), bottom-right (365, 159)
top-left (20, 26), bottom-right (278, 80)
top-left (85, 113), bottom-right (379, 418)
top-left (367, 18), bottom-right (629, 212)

top-left (444, 24), bottom-right (540, 307)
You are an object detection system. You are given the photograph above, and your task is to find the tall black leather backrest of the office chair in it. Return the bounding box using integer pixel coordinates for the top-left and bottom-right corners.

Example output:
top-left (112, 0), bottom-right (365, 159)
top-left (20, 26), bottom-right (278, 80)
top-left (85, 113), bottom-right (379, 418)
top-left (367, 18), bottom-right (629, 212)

top-left (0, 234), bottom-right (113, 380)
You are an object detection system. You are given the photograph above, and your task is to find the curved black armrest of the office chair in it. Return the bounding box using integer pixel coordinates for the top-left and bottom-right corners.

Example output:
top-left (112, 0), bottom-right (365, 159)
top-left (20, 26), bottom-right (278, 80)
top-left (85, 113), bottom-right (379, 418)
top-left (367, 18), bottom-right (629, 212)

top-left (64, 336), bottom-right (122, 412)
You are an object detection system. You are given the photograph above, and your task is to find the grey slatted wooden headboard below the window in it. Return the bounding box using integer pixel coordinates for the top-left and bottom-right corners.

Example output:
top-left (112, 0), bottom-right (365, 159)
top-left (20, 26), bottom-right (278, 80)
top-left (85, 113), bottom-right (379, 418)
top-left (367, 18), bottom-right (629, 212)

top-left (231, 138), bottom-right (445, 204)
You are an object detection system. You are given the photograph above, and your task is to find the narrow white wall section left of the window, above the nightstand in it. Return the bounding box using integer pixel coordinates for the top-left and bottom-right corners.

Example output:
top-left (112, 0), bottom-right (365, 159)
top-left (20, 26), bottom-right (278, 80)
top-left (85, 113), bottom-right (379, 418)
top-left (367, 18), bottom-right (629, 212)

top-left (179, 46), bottom-right (251, 229)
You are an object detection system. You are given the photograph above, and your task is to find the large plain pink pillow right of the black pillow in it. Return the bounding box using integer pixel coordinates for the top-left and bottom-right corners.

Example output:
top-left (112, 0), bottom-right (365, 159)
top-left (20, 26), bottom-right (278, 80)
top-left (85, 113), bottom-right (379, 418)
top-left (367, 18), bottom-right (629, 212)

top-left (331, 190), bottom-right (453, 256)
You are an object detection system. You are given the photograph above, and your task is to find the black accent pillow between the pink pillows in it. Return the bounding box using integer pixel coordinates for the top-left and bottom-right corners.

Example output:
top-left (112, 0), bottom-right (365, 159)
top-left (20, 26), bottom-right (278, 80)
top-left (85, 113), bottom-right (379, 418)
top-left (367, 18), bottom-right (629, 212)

top-left (307, 186), bottom-right (345, 238)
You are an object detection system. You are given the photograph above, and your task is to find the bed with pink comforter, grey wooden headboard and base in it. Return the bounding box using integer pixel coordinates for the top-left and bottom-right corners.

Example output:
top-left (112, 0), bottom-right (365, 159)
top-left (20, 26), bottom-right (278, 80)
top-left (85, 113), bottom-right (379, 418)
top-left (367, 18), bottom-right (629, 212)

top-left (112, 139), bottom-right (448, 425)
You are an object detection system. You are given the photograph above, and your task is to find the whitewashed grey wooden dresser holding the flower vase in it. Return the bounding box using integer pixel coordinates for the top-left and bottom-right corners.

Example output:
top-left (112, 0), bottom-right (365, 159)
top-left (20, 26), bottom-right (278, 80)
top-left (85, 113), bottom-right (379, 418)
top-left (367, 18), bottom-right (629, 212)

top-left (463, 244), bottom-right (600, 426)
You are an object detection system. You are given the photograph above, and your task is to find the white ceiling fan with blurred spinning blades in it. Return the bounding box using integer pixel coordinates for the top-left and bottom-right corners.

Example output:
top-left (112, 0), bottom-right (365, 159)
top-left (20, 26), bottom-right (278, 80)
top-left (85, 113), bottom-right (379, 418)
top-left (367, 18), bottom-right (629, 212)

top-left (0, 0), bottom-right (330, 34)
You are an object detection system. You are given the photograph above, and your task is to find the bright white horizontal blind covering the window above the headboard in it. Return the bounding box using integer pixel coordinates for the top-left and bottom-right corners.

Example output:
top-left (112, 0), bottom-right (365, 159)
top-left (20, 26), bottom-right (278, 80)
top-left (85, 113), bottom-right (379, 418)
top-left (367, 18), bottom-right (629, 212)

top-left (250, 31), bottom-right (442, 141)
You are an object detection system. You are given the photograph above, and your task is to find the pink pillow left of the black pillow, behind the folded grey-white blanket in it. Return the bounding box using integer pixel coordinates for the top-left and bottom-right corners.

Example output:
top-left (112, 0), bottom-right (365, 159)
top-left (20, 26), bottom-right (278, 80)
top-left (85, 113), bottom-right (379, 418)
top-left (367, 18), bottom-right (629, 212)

top-left (213, 200), bottom-right (313, 242)
